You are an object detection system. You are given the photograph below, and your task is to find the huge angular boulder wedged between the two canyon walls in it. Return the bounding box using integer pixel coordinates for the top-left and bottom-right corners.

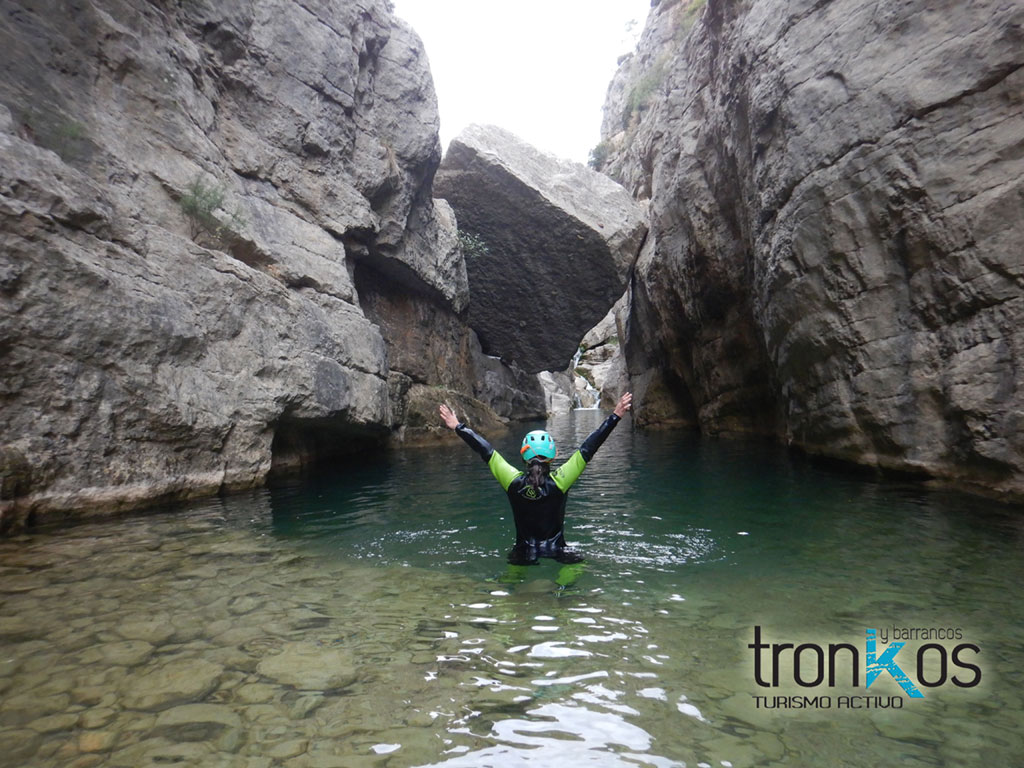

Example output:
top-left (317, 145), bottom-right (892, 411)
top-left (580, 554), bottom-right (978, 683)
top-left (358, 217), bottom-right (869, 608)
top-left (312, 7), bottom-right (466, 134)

top-left (434, 126), bottom-right (647, 373)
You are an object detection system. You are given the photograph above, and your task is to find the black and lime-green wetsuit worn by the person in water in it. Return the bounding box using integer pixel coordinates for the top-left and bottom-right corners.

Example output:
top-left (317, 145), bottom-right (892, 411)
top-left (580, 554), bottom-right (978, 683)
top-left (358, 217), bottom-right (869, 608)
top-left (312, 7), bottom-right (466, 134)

top-left (455, 414), bottom-right (620, 565)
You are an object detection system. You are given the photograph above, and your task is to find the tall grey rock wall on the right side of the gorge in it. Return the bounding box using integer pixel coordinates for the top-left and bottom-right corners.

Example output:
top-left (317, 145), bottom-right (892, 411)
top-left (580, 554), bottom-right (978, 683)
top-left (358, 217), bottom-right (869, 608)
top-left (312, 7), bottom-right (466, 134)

top-left (604, 0), bottom-right (1024, 495)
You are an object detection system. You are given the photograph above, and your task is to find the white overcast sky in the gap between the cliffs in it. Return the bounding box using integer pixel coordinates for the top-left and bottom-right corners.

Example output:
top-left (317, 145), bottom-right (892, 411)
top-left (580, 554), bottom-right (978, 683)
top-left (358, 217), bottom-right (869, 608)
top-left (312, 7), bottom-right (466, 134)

top-left (392, 0), bottom-right (650, 163)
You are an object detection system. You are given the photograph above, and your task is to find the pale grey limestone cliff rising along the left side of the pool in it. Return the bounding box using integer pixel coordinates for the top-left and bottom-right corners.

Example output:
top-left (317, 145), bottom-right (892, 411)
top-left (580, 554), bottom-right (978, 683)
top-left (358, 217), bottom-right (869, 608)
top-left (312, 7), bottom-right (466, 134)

top-left (0, 0), bottom-right (516, 527)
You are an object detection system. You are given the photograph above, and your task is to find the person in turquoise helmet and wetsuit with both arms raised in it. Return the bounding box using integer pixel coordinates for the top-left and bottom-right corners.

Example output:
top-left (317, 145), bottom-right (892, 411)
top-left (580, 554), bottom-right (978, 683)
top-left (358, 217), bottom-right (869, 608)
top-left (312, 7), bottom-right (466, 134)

top-left (439, 392), bottom-right (633, 565)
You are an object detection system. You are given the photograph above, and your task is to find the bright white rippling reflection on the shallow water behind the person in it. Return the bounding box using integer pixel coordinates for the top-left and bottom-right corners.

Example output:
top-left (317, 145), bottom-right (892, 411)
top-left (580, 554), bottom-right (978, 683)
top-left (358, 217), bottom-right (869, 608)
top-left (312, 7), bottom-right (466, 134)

top-left (407, 581), bottom-right (688, 768)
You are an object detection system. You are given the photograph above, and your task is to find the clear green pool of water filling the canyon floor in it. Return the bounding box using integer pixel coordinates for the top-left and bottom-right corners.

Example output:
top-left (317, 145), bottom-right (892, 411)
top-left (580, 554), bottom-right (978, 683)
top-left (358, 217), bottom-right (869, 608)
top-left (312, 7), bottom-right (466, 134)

top-left (0, 412), bottom-right (1024, 768)
